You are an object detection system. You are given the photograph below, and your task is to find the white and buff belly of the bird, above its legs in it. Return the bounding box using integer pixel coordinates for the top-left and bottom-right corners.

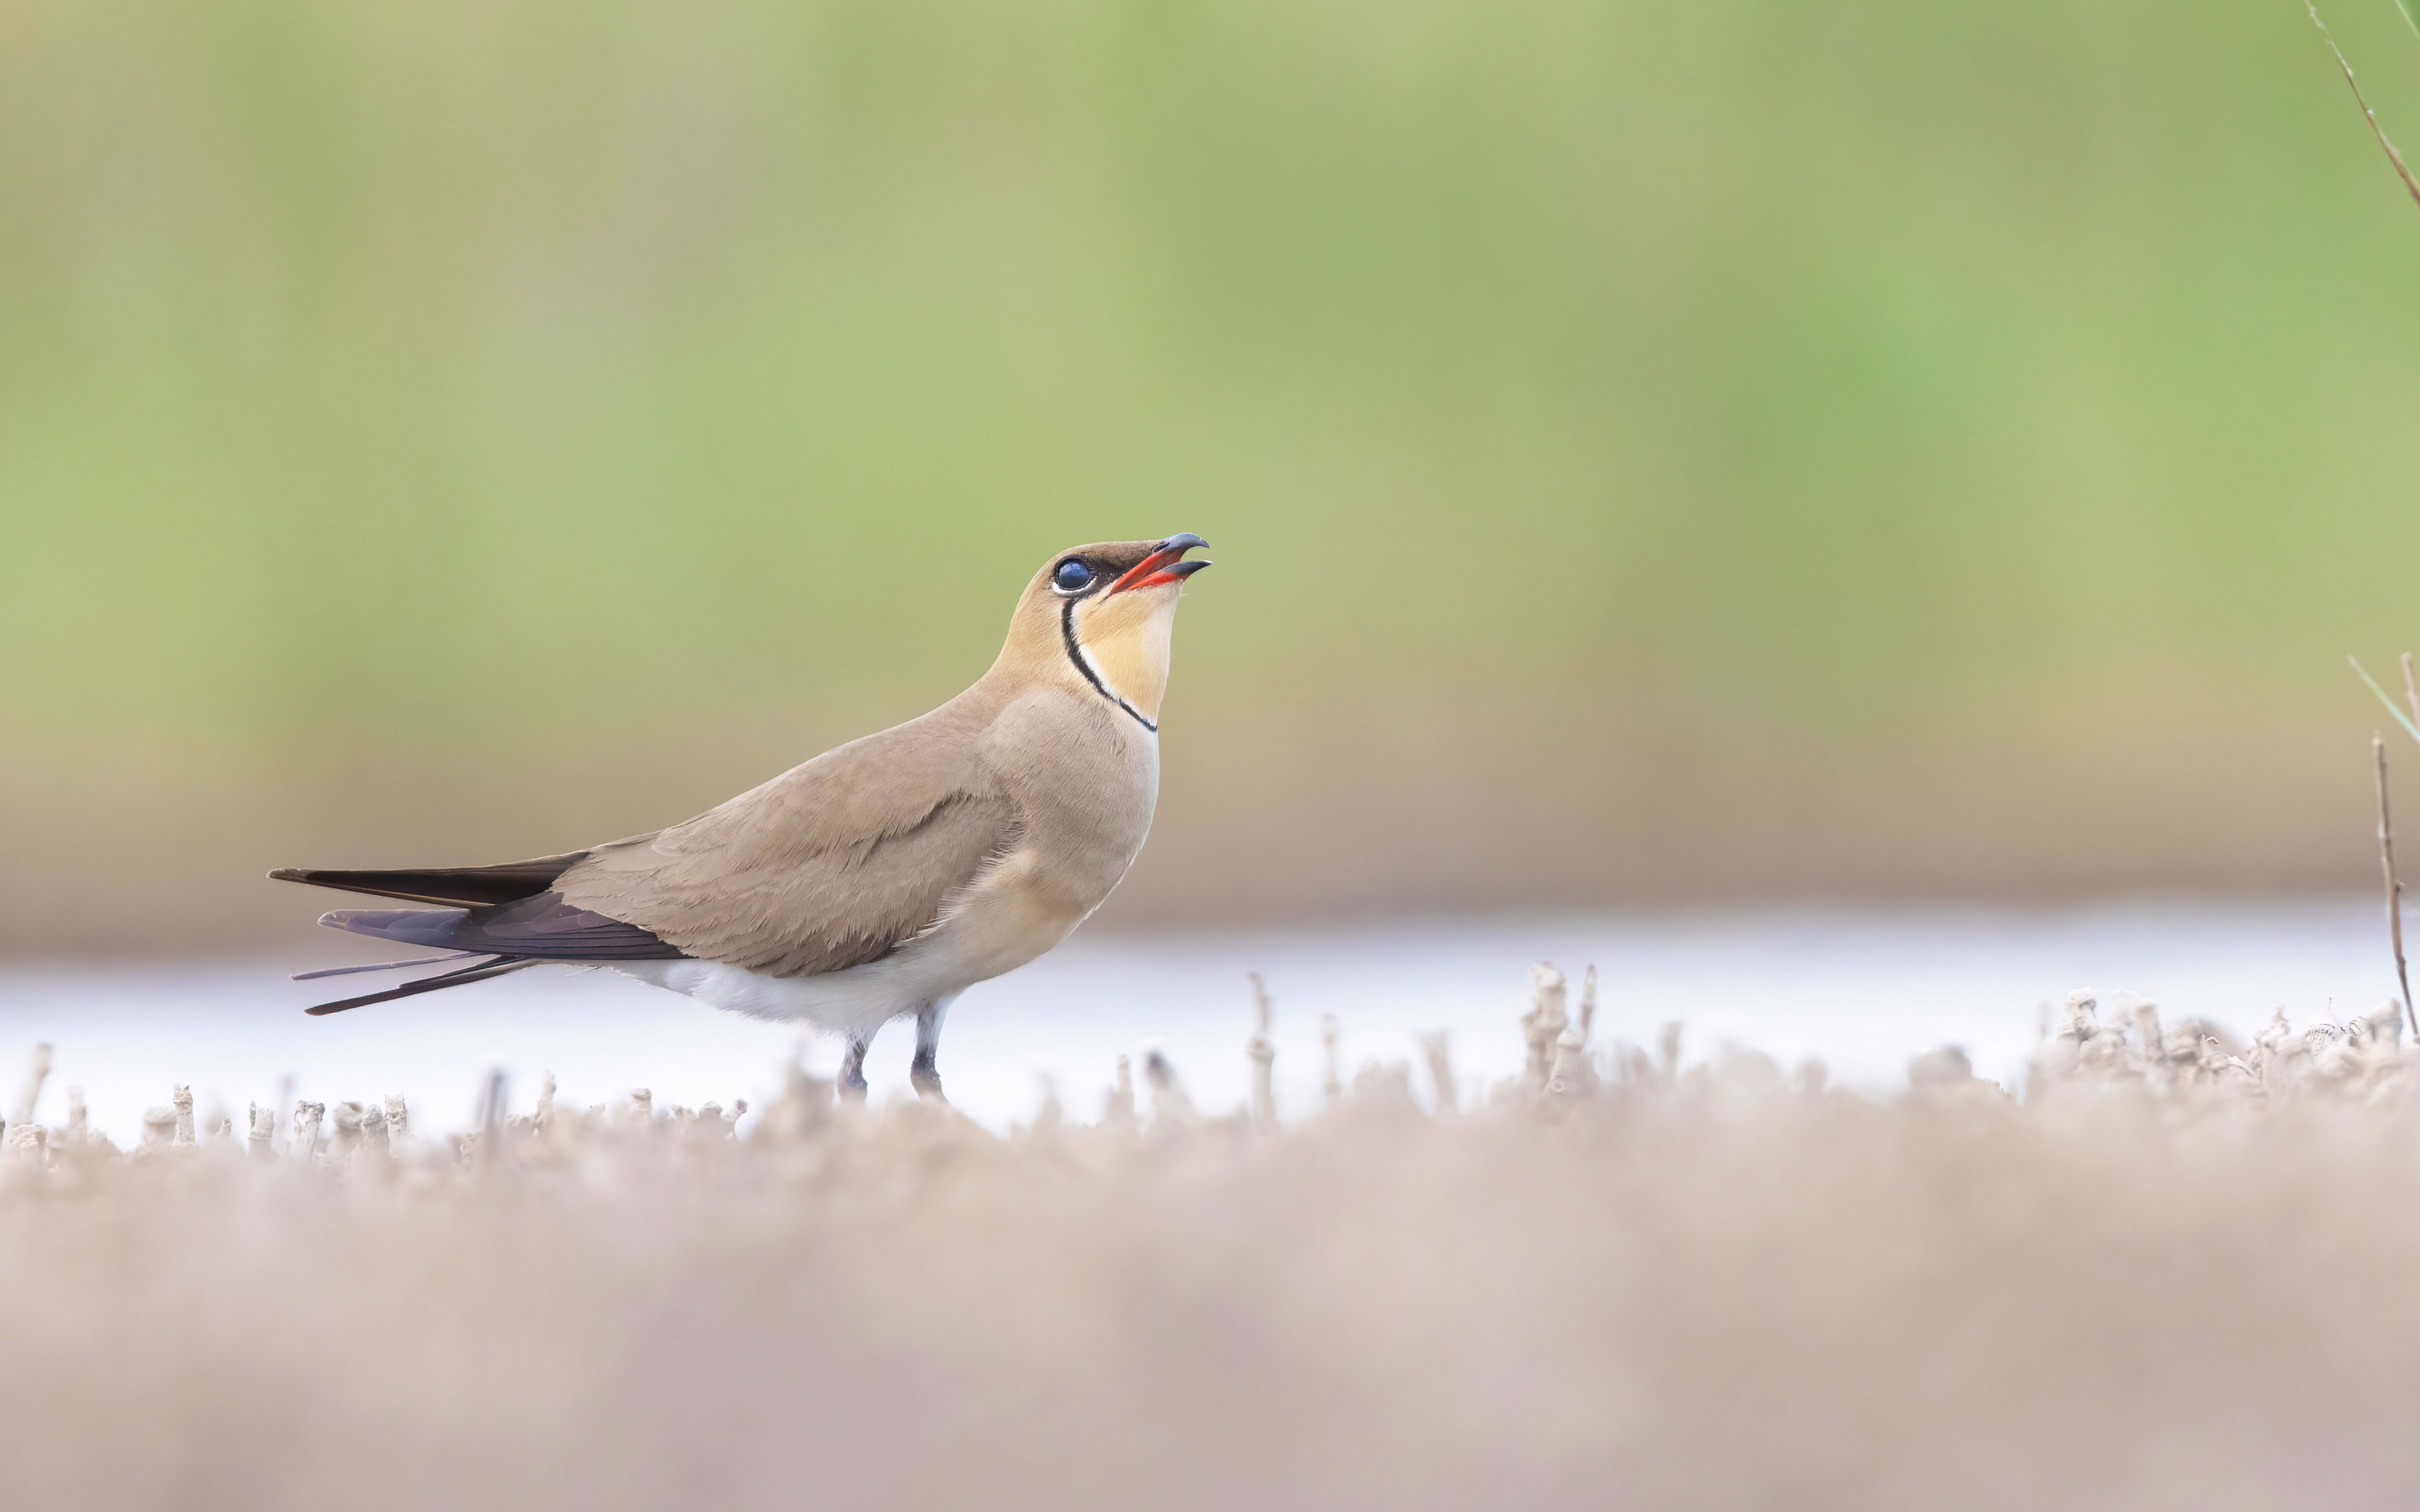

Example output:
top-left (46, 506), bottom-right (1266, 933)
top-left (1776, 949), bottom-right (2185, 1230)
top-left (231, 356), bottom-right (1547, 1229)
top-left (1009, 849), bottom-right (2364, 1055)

top-left (605, 852), bottom-right (1092, 1035)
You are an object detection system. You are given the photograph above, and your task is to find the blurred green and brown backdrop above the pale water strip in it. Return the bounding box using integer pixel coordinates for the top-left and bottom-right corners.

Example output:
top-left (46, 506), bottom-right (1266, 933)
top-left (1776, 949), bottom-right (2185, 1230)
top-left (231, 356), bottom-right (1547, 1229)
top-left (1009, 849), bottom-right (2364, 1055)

top-left (0, 0), bottom-right (2420, 956)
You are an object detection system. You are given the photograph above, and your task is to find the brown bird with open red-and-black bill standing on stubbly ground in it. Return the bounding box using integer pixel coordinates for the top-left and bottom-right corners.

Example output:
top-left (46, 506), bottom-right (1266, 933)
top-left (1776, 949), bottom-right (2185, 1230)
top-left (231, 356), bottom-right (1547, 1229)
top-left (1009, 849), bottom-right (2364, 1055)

top-left (269, 532), bottom-right (1210, 1103)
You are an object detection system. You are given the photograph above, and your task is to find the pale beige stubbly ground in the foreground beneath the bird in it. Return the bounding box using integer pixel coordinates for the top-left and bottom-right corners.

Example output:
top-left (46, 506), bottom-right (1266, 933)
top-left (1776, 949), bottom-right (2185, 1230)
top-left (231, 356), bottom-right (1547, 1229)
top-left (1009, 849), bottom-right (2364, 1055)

top-left (0, 977), bottom-right (2420, 1512)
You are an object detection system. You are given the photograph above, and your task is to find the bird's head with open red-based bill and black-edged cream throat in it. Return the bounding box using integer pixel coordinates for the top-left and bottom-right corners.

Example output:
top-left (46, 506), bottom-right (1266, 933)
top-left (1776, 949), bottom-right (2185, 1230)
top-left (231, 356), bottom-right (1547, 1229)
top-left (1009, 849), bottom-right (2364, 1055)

top-left (1002, 535), bottom-right (1210, 728)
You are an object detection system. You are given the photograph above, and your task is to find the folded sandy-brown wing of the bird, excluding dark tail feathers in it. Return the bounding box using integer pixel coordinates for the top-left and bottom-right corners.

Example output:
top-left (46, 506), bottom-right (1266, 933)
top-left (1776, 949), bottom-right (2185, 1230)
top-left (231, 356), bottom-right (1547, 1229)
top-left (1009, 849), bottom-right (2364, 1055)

top-left (554, 716), bottom-right (1016, 977)
